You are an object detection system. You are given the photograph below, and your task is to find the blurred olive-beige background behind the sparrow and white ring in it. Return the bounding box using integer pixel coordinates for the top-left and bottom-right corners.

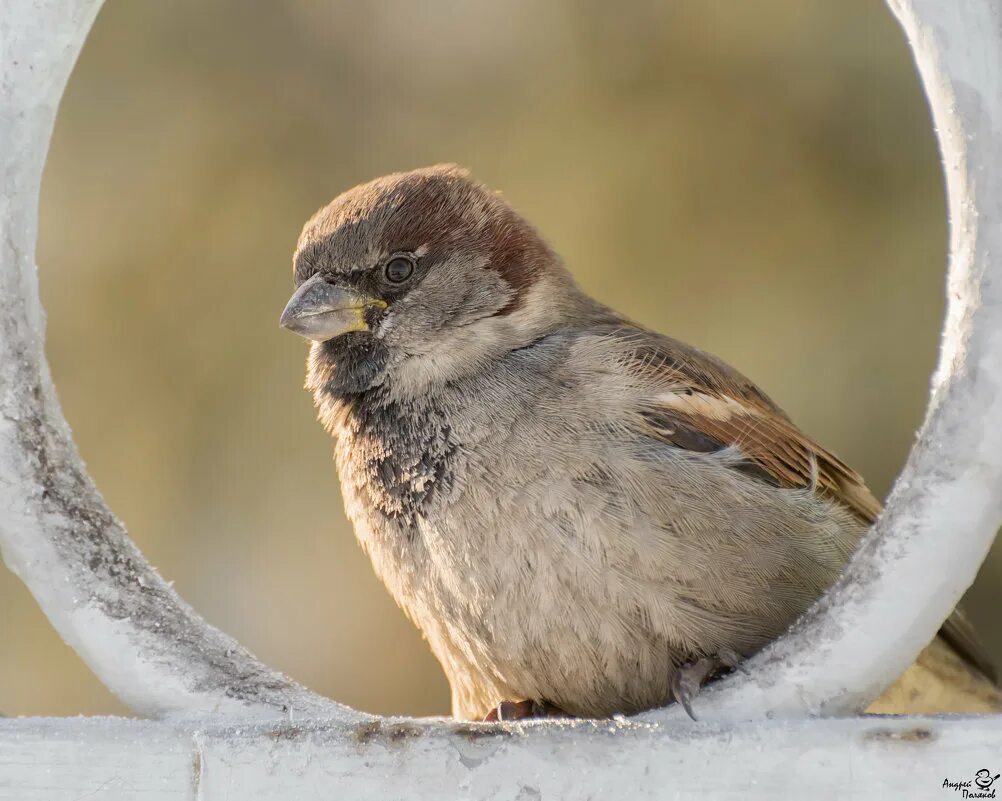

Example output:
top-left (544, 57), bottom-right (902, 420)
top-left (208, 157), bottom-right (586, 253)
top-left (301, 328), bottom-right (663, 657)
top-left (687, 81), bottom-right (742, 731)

top-left (0, 0), bottom-right (1002, 715)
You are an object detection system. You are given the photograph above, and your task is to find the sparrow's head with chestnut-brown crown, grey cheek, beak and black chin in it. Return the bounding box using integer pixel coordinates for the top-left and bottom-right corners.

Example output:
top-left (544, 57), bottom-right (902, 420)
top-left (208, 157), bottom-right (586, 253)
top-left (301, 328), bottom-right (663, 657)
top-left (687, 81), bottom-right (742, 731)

top-left (282, 165), bottom-right (583, 401)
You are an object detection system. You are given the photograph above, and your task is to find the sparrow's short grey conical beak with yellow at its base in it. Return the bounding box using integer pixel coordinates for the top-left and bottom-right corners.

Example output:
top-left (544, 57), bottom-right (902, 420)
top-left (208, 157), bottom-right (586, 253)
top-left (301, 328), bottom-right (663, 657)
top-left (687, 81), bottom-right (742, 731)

top-left (279, 275), bottom-right (386, 342)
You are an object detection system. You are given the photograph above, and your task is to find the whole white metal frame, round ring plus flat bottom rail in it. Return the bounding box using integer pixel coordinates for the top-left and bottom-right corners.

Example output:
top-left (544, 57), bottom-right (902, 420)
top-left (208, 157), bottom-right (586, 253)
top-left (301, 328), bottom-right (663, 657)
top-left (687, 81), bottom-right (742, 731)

top-left (0, 0), bottom-right (1002, 799)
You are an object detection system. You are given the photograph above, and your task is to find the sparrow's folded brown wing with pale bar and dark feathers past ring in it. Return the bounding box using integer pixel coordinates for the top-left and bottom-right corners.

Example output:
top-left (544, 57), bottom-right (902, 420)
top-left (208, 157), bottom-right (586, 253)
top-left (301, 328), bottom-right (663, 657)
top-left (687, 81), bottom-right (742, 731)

top-left (616, 330), bottom-right (997, 683)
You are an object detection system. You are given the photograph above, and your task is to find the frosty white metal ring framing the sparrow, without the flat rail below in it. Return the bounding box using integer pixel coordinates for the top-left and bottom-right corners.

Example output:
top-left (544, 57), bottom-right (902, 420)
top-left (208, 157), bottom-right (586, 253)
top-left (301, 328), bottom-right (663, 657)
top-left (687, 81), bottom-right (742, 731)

top-left (0, 0), bottom-right (1002, 733)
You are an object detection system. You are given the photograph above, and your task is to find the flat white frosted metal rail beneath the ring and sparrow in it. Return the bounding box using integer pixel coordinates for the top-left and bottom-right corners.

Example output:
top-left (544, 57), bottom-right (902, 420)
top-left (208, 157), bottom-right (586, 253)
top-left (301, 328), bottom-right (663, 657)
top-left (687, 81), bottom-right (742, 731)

top-left (7, 718), bottom-right (1002, 801)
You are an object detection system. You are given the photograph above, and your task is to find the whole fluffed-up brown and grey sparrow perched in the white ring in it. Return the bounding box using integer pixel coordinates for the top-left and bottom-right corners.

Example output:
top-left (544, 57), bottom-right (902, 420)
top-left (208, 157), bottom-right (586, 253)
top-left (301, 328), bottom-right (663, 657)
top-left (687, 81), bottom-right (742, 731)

top-left (281, 164), bottom-right (1002, 720)
